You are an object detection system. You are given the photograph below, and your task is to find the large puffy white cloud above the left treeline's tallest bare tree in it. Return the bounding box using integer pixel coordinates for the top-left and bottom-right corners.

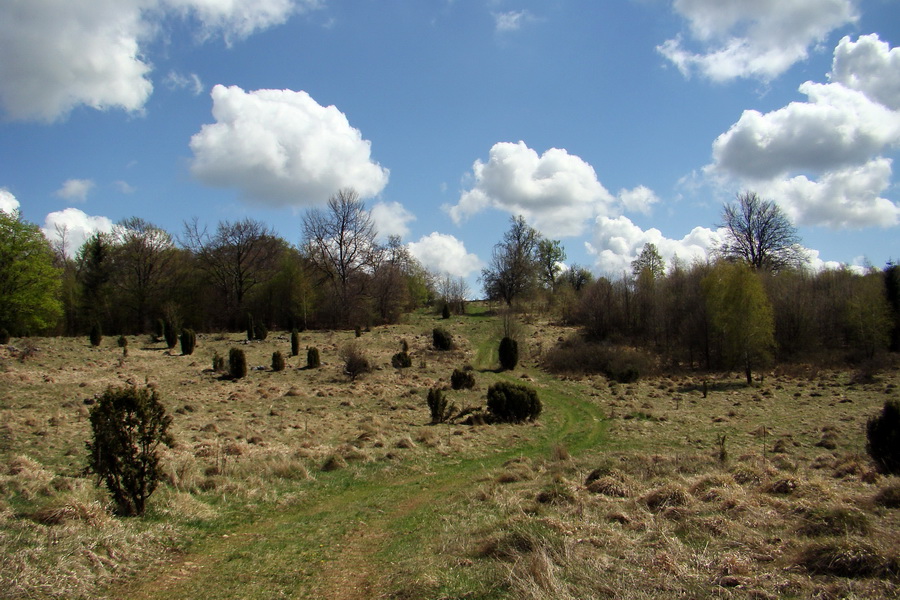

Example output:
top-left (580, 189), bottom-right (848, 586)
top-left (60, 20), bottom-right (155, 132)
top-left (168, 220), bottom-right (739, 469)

top-left (190, 85), bottom-right (389, 207)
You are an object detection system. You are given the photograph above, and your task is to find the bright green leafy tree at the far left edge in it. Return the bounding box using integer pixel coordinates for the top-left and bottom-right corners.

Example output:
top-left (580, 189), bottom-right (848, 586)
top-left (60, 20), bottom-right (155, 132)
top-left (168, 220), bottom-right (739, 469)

top-left (0, 211), bottom-right (62, 335)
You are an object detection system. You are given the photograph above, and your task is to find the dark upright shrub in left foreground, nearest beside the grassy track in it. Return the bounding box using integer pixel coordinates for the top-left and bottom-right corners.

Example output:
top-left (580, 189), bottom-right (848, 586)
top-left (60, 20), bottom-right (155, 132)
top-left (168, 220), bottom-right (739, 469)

top-left (87, 387), bottom-right (172, 516)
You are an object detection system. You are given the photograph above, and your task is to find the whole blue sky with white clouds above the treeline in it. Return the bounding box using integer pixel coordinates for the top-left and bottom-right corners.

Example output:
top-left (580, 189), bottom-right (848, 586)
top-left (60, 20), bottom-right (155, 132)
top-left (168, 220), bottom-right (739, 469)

top-left (0, 0), bottom-right (900, 296)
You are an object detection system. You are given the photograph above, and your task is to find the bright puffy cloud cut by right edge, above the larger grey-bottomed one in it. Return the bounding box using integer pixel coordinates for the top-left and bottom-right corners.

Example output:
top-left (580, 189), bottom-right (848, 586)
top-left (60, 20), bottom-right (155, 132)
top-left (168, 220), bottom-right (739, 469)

top-left (828, 33), bottom-right (900, 110)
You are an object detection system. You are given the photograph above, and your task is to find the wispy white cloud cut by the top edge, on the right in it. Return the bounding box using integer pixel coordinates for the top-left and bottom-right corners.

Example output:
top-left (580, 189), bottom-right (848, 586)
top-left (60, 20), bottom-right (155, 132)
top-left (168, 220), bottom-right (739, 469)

top-left (657, 0), bottom-right (858, 82)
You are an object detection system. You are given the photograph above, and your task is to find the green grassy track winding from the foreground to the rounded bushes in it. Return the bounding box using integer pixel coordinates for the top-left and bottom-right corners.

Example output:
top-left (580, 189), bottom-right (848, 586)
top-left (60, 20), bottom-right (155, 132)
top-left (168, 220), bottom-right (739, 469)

top-left (105, 375), bottom-right (604, 600)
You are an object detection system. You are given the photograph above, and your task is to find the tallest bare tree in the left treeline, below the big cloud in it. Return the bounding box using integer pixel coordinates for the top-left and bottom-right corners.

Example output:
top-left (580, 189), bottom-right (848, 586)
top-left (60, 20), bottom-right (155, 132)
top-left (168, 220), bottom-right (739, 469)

top-left (303, 189), bottom-right (381, 325)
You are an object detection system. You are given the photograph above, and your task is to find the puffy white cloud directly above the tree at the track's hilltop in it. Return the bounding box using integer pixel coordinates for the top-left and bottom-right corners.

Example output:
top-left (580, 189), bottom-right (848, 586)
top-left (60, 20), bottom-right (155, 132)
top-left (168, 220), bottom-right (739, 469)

top-left (447, 142), bottom-right (615, 237)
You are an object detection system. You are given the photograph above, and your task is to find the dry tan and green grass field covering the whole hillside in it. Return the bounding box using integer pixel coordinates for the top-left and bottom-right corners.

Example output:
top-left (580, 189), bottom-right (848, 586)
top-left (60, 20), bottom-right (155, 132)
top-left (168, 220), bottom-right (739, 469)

top-left (0, 312), bottom-right (900, 599)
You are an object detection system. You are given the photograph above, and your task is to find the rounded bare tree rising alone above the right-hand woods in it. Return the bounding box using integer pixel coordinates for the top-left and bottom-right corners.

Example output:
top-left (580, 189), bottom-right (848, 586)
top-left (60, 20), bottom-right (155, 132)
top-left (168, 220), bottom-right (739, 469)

top-left (719, 192), bottom-right (806, 271)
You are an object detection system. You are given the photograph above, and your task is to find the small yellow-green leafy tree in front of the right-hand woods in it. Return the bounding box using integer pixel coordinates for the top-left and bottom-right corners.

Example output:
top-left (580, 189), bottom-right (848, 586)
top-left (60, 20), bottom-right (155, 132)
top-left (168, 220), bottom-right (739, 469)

top-left (702, 262), bottom-right (775, 385)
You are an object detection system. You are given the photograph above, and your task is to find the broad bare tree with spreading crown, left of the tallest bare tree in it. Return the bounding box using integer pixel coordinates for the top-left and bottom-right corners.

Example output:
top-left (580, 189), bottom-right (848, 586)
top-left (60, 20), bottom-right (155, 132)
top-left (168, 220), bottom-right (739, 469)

top-left (182, 218), bottom-right (285, 326)
